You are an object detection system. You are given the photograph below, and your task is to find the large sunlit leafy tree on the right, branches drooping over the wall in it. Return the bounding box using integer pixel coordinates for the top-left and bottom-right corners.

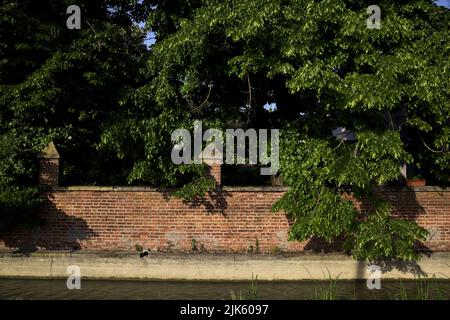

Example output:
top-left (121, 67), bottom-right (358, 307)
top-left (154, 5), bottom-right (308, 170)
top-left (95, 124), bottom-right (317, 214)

top-left (100, 0), bottom-right (450, 260)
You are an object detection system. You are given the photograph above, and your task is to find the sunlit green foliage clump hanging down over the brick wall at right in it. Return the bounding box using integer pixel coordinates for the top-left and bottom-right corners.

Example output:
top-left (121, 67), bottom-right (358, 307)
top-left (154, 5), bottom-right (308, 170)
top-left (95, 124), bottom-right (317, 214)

top-left (273, 126), bottom-right (427, 260)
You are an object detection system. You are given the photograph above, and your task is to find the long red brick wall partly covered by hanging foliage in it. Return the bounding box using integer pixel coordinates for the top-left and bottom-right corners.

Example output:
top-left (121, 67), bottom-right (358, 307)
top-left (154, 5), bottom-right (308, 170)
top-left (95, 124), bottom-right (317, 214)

top-left (0, 187), bottom-right (450, 252)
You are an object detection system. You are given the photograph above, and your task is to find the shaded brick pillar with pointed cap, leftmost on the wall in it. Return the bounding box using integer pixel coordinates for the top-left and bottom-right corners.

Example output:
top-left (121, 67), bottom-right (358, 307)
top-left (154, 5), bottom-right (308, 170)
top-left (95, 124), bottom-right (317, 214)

top-left (39, 142), bottom-right (59, 188)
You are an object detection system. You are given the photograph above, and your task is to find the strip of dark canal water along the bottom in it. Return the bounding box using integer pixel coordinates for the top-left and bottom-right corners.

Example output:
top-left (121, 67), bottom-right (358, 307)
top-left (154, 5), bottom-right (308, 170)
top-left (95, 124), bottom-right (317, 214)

top-left (0, 279), bottom-right (450, 300)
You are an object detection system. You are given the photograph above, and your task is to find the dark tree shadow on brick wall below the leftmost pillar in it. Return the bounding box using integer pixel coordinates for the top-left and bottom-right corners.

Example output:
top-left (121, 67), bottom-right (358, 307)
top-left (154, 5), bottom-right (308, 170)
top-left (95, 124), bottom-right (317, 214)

top-left (0, 193), bottom-right (96, 253)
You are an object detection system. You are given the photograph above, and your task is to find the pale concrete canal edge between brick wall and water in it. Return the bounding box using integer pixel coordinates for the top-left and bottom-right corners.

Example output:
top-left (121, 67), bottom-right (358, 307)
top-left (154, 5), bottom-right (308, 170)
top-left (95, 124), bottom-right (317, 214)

top-left (0, 252), bottom-right (450, 281)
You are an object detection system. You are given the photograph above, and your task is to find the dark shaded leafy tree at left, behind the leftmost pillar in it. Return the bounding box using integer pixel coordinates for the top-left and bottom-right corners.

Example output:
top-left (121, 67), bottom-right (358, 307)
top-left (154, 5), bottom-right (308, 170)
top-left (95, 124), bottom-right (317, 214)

top-left (0, 0), bottom-right (145, 227)
